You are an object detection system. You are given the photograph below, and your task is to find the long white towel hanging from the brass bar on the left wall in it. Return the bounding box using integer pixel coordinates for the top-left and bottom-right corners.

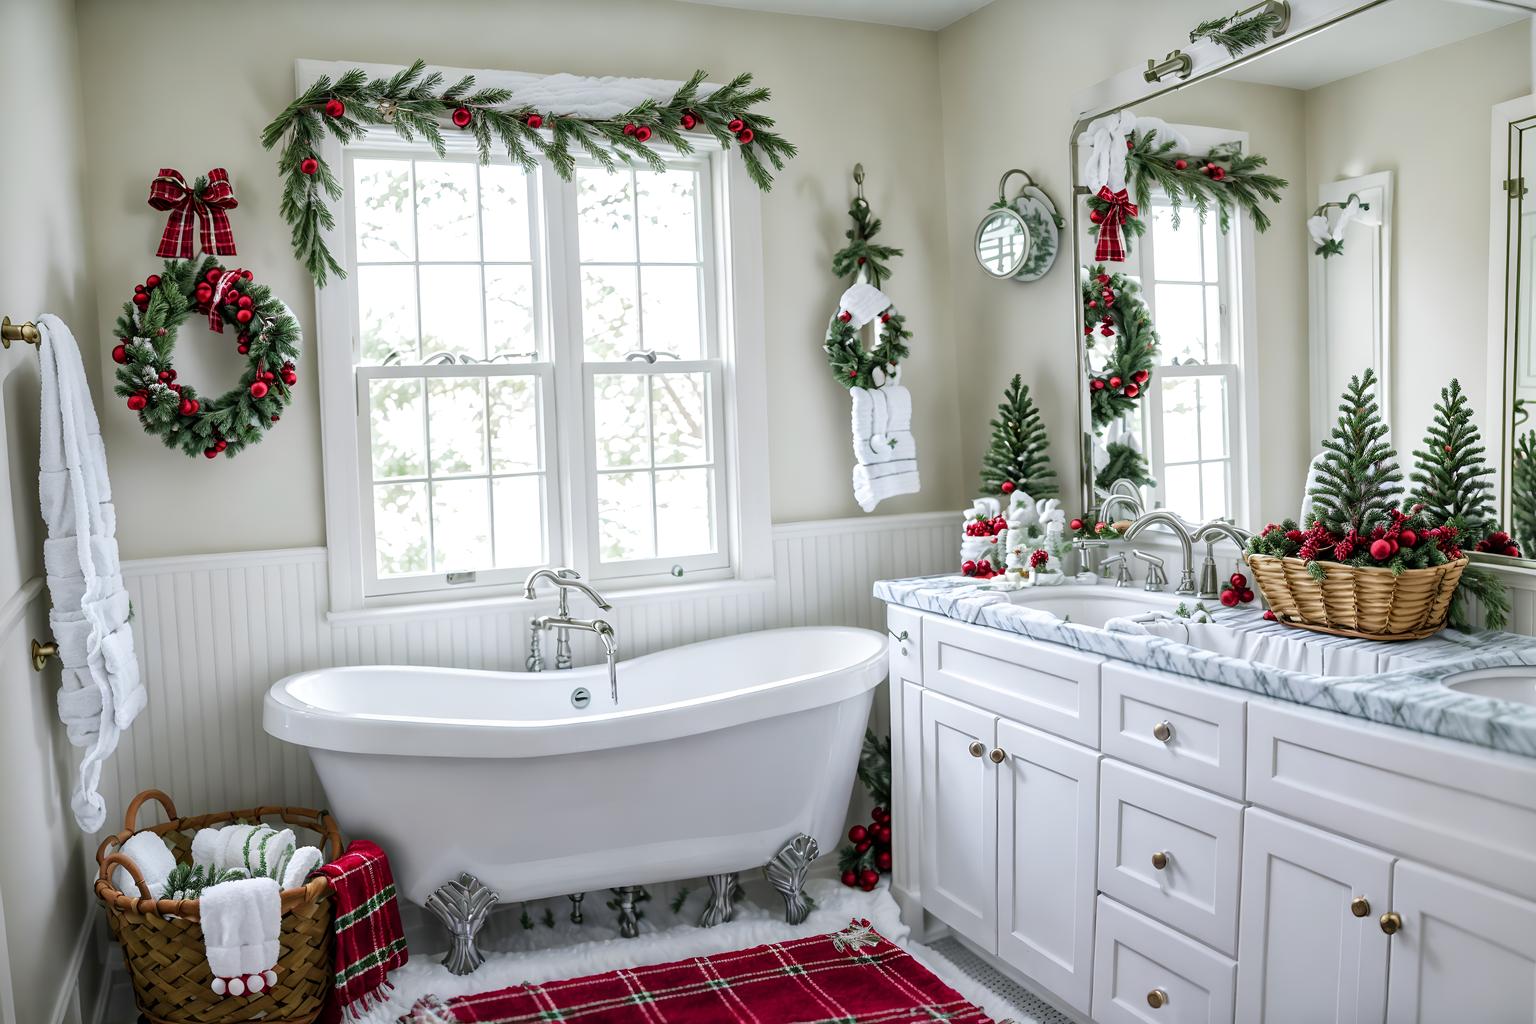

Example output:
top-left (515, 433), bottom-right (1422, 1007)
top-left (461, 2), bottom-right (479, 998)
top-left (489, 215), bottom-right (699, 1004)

top-left (37, 313), bottom-right (146, 832)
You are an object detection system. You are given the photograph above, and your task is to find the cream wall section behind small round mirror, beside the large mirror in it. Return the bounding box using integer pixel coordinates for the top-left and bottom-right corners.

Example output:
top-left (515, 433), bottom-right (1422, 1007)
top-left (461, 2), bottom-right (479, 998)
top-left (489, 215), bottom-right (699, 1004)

top-left (938, 0), bottom-right (1212, 504)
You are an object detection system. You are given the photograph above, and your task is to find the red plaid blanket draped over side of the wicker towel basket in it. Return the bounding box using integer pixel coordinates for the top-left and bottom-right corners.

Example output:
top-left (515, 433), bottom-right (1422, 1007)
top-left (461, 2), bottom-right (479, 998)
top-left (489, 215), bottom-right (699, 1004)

top-left (319, 840), bottom-right (410, 1019)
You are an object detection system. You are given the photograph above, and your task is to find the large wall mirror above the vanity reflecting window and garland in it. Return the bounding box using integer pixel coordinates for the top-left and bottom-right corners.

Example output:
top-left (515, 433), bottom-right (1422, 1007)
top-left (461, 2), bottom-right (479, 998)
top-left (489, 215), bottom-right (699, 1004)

top-left (1072, 0), bottom-right (1536, 568)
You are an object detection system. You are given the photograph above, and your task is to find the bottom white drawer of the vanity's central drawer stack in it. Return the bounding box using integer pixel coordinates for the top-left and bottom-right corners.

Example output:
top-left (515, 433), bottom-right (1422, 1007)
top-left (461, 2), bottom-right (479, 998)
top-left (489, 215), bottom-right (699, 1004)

top-left (1094, 897), bottom-right (1238, 1024)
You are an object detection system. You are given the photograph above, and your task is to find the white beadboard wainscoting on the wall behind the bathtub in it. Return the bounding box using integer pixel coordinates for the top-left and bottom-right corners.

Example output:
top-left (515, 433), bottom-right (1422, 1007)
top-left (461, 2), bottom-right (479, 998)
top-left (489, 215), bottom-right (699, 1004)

top-left (101, 513), bottom-right (960, 829)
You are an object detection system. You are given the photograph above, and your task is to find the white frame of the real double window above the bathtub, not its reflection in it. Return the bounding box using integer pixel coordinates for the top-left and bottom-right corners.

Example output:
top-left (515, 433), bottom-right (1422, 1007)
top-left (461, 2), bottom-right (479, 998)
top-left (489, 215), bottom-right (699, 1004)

top-left (305, 60), bottom-right (773, 619)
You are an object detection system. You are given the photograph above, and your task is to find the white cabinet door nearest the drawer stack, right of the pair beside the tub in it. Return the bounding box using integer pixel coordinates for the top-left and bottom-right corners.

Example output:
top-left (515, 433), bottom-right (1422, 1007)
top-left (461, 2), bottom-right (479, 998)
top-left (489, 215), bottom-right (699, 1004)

top-left (997, 718), bottom-right (1098, 1013)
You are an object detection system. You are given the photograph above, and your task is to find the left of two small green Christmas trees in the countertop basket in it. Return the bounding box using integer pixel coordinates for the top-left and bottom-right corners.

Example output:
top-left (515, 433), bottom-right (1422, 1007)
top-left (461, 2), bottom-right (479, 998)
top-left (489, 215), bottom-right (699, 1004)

top-left (1307, 368), bottom-right (1402, 543)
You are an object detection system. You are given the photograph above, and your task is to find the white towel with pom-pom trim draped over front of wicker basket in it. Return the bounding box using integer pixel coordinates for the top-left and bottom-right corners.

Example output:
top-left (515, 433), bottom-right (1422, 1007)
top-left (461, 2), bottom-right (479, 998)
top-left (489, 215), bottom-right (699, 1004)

top-left (198, 878), bottom-right (283, 996)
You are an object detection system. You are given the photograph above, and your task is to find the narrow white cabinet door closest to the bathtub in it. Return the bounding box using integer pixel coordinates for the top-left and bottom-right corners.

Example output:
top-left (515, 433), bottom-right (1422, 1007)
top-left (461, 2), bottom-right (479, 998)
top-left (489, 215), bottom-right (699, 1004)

top-left (922, 691), bottom-right (998, 953)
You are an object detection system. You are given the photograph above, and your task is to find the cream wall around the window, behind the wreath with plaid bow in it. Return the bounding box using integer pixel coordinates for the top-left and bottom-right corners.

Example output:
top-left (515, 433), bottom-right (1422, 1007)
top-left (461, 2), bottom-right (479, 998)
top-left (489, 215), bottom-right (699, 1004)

top-left (80, 0), bottom-right (965, 557)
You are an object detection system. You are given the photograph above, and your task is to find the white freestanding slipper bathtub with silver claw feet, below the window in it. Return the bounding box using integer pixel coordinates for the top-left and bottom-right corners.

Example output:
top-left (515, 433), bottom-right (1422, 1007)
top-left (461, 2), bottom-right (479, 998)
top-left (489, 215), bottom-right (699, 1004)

top-left (263, 628), bottom-right (886, 903)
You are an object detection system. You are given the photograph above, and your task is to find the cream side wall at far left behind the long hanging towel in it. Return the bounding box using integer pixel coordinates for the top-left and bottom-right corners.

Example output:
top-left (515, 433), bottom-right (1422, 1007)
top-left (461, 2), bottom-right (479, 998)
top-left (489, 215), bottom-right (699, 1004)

top-left (0, 0), bottom-right (109, 1024)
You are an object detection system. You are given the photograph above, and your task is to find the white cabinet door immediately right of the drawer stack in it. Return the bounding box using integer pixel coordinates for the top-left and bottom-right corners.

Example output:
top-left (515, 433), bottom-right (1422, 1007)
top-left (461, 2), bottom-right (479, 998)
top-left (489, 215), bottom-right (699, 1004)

top-left (1236, 808), bottom-right (1400, 1024)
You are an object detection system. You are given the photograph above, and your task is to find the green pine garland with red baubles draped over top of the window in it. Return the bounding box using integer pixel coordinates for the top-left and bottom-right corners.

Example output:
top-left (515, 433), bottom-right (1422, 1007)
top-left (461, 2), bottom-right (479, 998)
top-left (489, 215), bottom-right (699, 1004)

top-left (261, 60), bottom-right (796, 286)
